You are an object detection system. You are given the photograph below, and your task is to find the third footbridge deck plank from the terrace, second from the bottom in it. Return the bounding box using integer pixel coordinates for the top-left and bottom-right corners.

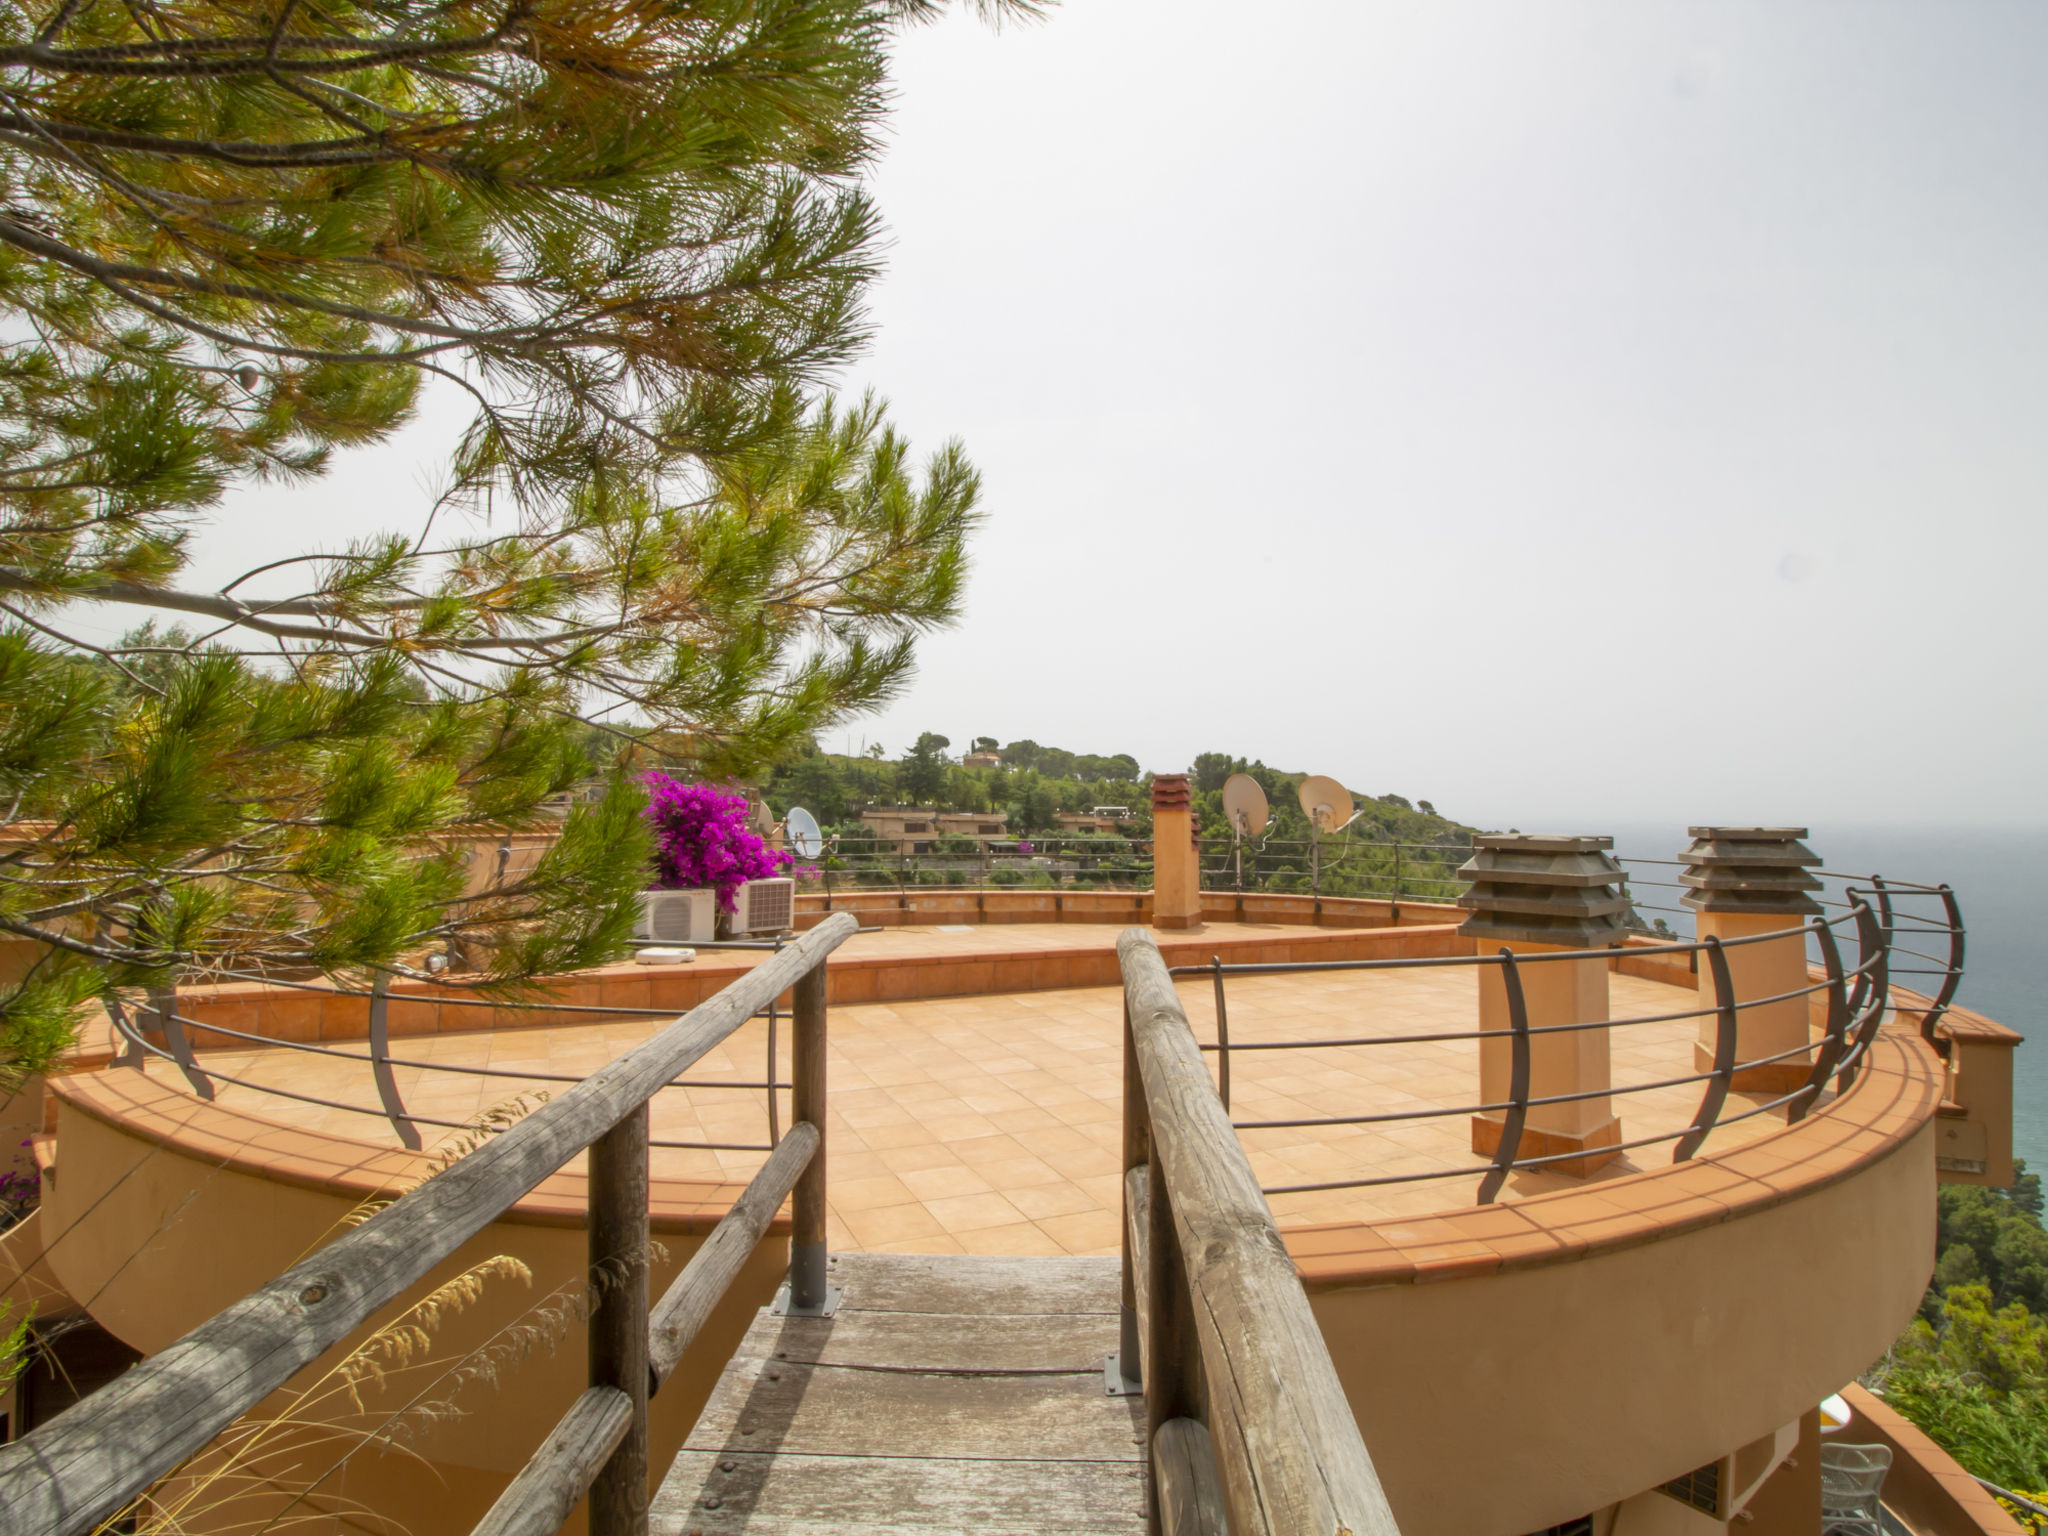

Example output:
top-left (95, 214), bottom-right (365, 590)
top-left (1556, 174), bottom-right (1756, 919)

top-left (684, 1360), bottom-right (1143, 1462)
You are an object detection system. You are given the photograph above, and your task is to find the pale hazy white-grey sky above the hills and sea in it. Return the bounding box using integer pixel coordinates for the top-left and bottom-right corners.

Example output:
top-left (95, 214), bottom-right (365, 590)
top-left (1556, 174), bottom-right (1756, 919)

top-left (172, 0), bottom-right (2048, 831)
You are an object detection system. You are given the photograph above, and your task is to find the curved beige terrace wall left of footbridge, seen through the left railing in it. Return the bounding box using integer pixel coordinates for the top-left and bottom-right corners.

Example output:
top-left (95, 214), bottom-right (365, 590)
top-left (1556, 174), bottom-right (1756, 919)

top-left (41, 1104), bottom-right (788, 1536)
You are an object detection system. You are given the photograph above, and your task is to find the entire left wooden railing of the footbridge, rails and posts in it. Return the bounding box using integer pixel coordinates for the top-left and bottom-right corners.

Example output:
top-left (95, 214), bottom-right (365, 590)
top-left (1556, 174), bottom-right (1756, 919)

top-left (0, 913), bottom-right (856, 1536)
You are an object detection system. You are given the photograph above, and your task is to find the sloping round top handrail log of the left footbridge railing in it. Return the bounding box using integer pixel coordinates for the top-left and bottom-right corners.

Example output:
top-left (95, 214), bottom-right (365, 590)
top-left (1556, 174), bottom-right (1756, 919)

top-left (0, 913), bottom-right (858, 1536)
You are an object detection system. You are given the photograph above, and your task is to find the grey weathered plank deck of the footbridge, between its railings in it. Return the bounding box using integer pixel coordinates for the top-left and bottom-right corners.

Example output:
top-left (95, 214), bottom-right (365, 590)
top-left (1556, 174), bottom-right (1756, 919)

top-left (651, 1253), bottom-right (1145, 1536)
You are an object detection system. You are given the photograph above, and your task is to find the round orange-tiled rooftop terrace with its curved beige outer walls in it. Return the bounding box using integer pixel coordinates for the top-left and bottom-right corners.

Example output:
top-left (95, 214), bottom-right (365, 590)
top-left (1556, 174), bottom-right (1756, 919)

top-left (8, 856), bottom-right (2015, 1536)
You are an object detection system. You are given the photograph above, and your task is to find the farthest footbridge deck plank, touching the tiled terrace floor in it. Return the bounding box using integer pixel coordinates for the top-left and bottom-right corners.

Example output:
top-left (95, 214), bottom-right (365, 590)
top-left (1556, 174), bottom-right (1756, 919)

top-left (831, 1253), bottom-right (1118, 1317)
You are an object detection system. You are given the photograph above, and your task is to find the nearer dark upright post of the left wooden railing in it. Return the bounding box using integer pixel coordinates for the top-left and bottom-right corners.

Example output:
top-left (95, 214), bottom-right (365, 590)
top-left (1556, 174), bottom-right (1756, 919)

top-left (590, 1100), bottom-right (653, 1536)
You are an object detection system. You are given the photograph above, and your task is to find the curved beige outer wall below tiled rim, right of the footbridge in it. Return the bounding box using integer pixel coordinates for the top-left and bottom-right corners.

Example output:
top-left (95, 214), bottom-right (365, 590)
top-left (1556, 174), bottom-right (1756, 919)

top-left (1311, 1124), bottom-right (1935, 1536)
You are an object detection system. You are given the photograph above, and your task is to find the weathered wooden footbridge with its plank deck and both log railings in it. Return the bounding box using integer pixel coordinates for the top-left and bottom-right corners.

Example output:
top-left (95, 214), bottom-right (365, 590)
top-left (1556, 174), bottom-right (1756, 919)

top-left (0, 913), bottom-right (1397, 1536)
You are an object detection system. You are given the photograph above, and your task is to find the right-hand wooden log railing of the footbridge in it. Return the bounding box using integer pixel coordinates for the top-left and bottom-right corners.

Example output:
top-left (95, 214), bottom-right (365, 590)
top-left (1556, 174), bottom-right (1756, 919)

top-left (1112, 928), bottom-right (1399, 1536)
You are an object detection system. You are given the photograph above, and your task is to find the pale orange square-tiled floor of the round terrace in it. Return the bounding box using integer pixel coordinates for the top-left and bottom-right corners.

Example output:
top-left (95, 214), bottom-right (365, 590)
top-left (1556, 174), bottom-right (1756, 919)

top-left (150, 934), bottom-right (1782, 1253)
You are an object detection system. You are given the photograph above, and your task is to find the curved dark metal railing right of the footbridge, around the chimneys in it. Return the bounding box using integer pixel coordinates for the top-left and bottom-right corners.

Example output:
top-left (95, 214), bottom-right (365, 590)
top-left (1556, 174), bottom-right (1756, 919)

top-left (1171, 877), bottom-right (1966, 1204)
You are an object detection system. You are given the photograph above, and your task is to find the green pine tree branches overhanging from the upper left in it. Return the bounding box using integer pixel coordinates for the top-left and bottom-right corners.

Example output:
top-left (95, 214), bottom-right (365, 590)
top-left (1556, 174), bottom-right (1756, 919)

top-left (0, 0), bottom-right (1032, 1077)
